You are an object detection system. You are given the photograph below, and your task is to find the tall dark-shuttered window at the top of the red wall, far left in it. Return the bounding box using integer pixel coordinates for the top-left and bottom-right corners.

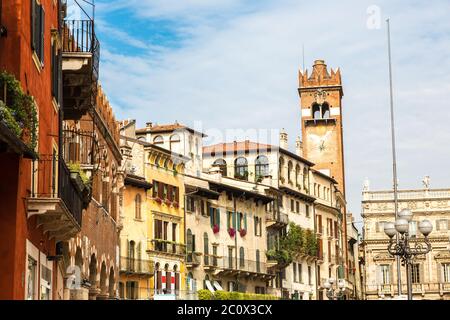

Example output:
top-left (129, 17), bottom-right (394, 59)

top-left (31, 0), bottom-right (45, 65)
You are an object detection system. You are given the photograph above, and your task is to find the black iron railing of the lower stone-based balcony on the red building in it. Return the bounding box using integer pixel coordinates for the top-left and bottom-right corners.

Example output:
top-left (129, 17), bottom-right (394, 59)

top-left (31, 155), bottom-right (86, 227)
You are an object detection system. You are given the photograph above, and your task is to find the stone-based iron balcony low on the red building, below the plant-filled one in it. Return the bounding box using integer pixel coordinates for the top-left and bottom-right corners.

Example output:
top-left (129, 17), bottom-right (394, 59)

top-left (27, 155), bottom-right (89, 241)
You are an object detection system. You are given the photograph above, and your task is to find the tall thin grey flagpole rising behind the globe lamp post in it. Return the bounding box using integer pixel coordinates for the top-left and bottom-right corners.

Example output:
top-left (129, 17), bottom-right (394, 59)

top-left (386, 19), bottom-right (402, 296)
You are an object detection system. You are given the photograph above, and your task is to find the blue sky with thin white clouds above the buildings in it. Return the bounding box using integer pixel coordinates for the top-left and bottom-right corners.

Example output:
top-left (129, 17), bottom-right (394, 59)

top-left (86, 0), bottom-right (450, 228)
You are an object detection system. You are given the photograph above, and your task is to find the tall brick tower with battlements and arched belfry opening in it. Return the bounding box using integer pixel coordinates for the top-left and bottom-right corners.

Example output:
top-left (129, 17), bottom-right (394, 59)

top-left (298, 60), bottom-right (345, 195)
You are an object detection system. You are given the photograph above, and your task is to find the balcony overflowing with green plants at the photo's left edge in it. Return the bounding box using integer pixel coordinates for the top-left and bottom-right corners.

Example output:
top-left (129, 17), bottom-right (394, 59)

top-left (0, 71), bottom-right (38, 159)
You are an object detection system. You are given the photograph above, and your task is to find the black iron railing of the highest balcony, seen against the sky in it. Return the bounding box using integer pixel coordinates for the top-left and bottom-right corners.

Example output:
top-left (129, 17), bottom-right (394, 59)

top-left (62, 20), bottom-right (100, 80)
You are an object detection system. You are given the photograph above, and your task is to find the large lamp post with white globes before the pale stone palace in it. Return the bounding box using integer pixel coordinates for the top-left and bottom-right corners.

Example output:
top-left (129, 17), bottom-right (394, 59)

top-left (384, 209), bottom-right (433, 300)
